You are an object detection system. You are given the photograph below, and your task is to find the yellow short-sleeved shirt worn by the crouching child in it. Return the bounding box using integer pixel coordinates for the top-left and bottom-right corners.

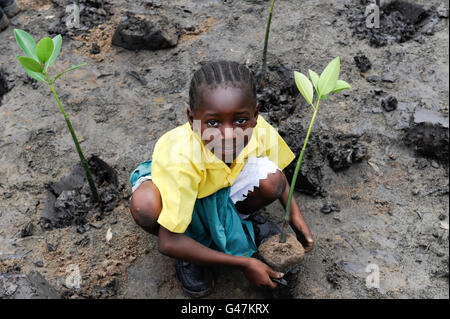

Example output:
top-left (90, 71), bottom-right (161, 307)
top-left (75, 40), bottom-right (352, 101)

top-left (152, 116), bottom-right (295, 233)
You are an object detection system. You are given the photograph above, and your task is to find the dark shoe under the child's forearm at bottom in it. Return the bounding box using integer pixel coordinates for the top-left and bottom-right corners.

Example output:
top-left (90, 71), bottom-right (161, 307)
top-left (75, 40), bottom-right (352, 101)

top-left (175, 260), bottom-right (214, 298)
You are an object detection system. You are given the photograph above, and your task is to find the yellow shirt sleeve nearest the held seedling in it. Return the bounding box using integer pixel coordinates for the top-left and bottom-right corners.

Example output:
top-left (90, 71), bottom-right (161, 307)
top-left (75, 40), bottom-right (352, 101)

top-left (258, 116), bottom-right (295, 170)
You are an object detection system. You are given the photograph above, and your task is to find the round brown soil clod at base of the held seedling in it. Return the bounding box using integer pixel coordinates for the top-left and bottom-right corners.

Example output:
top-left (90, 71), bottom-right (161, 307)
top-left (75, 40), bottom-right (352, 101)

top-left (258, 234), bottom-right (305, 274)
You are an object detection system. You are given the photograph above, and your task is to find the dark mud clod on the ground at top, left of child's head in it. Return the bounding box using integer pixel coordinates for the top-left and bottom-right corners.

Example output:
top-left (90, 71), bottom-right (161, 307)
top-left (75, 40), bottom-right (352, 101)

top-left (112, 12), bottom-right (179, 50)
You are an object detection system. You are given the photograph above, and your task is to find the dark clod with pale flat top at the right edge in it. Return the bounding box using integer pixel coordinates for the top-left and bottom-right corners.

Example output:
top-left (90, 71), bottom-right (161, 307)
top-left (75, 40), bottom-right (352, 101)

top-left (404, 108), bottom-right (449, 165)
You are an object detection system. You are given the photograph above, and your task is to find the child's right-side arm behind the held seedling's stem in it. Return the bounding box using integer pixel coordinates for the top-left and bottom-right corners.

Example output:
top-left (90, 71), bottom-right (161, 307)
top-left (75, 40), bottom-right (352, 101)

top-left (280, 174), bottom-right (314, 252)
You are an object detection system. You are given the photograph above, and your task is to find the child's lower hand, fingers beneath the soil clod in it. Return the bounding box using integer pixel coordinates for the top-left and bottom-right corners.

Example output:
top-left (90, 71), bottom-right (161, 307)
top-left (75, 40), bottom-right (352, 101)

top-left (243, 258), bottom-right (284, 289)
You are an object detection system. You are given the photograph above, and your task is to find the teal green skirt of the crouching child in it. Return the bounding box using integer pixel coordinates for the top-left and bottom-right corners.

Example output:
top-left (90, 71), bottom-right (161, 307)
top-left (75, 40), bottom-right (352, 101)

top-left (130, 161), bottom-right (257, 257)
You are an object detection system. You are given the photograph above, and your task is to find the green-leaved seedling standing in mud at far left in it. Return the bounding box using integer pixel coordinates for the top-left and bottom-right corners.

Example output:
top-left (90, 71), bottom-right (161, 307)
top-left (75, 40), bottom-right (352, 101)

top-left (14, 29), bottom-right (100, 202)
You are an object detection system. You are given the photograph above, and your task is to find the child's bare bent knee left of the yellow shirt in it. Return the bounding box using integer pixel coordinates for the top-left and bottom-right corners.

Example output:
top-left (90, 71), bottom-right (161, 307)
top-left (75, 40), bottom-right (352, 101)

top-left (130, 180), bottom-right (162, 236)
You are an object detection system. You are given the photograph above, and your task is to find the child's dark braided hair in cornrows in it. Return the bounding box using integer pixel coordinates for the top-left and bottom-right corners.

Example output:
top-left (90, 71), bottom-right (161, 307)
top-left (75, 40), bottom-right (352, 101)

top-left (189, 61), bottom-right (256, 110)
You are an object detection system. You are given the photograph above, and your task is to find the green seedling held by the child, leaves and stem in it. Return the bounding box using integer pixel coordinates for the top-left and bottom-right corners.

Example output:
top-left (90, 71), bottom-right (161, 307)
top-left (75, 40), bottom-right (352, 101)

top-left (280, 57), bottom-right (350, 243)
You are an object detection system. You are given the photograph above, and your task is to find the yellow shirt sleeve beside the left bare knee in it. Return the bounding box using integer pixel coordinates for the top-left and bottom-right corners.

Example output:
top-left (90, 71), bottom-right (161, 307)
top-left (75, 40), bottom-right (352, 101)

top-left (152, 136), bottom-right (201, 233)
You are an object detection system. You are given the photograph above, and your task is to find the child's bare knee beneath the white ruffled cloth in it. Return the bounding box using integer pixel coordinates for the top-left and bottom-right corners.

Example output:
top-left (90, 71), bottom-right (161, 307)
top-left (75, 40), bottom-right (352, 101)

top-left (235, 170), bottom-right (287, 214)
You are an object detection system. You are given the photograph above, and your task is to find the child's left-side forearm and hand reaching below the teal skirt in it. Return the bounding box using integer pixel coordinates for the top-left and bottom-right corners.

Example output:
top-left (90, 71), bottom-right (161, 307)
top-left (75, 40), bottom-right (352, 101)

top-left (158, 226), bottom-right (283, 288)
